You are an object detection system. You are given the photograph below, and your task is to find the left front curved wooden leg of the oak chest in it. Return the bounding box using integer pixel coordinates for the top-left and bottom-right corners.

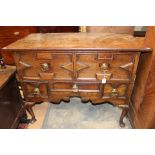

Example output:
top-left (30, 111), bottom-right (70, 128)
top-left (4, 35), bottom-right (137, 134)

top-left (24, 101), bottom-right (37, 124)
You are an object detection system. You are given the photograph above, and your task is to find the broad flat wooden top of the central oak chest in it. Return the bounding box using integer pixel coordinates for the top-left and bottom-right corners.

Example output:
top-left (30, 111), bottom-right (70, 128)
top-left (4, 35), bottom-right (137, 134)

top-left (3, 33), bottom-right (150, 51)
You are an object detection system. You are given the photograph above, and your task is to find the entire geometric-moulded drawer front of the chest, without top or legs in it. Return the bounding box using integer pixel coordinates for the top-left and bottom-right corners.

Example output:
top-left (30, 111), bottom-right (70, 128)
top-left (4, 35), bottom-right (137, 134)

top-left (14, 51), bottom-right (139, 104)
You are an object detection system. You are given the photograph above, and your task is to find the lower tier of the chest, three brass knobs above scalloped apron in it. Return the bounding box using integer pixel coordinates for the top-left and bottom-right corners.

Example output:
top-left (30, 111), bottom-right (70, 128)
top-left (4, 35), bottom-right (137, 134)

top-left (22, 81), bottom-right (133, 105)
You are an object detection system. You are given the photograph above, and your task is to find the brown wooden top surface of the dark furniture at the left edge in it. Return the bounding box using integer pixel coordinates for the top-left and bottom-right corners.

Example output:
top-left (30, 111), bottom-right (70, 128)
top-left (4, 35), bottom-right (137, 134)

top-left (0, 66), bottom-right (16, 89)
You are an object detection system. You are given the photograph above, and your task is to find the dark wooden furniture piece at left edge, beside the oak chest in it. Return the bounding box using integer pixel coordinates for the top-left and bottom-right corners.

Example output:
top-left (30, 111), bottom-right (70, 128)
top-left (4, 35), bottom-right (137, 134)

top-left (0, 67), bottom-right (25, 129)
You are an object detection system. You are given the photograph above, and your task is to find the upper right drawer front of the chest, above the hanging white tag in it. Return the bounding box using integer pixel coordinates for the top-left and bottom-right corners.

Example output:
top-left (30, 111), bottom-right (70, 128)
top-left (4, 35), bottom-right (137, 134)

top-left (77, 52), bottom-right (139, 81)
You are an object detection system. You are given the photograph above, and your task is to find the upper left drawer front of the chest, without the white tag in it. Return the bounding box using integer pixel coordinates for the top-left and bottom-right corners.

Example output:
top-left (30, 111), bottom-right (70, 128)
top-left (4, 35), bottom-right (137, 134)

top-left (14, 52), bottom-right (73, 80)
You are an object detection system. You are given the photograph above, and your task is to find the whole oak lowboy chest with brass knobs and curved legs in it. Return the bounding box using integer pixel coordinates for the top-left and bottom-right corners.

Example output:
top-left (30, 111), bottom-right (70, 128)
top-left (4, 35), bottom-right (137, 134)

top-left (4, 33), bottom-right (148, 127)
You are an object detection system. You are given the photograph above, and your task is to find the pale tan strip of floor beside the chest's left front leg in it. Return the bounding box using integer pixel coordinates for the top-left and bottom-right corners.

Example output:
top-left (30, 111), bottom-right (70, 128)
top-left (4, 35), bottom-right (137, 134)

top-left (28, 102), bottom-right (49, 129)
